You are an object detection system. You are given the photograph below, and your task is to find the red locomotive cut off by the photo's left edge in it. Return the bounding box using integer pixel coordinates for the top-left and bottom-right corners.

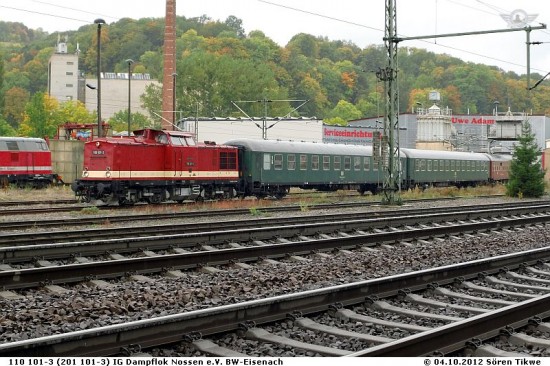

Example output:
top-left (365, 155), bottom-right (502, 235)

top-left (0, 137), bottom-right (57, 188)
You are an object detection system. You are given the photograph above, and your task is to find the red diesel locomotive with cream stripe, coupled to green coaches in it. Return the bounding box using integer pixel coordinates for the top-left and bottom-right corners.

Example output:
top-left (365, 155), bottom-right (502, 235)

top-left (72, 129), bottom-right (239, 204)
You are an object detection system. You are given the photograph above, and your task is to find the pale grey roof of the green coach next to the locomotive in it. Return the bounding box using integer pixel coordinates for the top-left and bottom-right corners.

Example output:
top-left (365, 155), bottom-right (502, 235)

top-left (224, 139), bottom-right (372, 155)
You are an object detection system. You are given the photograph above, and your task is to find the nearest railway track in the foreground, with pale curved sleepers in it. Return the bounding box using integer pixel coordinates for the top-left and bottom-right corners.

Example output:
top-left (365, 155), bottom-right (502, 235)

top-left (0, 248), bottom-right (550, 357)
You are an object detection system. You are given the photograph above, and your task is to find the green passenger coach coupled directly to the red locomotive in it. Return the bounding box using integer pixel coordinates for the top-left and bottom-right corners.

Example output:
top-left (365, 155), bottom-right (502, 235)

top-left (225, 139), bottom-right (383, 198)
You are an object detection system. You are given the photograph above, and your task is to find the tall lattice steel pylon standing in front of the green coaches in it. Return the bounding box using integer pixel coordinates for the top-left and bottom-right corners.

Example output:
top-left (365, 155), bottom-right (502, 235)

top-left (376, 0), bottom-right (401, 205)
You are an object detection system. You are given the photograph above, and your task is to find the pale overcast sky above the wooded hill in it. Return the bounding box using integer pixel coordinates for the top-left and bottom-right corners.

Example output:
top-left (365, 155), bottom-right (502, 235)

top-left (0, 0), bottom-right (550, 75)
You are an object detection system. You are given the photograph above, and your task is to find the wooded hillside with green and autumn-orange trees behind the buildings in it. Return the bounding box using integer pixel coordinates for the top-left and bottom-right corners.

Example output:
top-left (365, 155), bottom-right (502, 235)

top-left (0, 16), bottom-right (550, 137)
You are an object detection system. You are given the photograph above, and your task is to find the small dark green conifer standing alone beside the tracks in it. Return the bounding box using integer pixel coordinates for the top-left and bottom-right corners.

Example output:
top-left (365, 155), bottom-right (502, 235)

top-left (506, 121), bottom-right (544, 197)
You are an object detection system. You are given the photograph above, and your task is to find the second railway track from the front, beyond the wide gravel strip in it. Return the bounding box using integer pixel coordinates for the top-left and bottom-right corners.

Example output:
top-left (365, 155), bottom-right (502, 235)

top-left (0, 204), bottom-right (550, 276)
